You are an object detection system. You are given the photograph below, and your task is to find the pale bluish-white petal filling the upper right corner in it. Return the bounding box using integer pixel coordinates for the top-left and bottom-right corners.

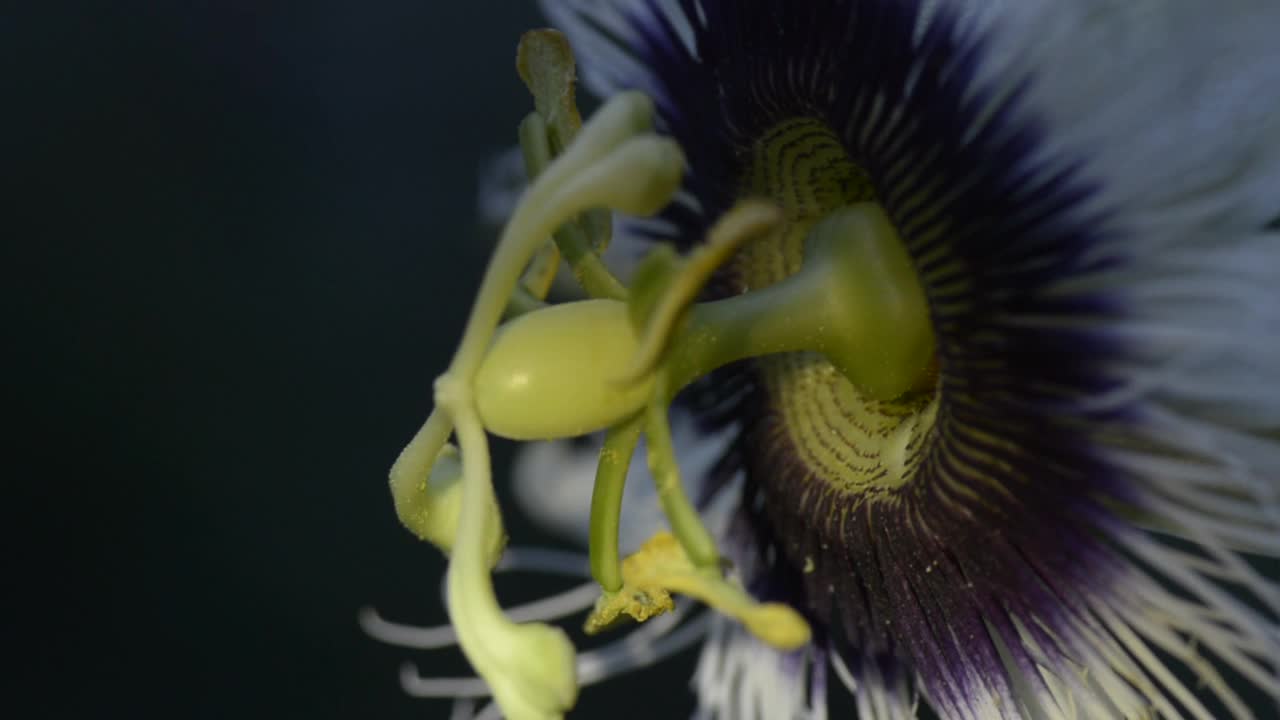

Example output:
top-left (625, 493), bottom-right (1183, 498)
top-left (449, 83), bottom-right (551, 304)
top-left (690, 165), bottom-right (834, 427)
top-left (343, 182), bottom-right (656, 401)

top-left (986, 0), bottom-right (1280, 233)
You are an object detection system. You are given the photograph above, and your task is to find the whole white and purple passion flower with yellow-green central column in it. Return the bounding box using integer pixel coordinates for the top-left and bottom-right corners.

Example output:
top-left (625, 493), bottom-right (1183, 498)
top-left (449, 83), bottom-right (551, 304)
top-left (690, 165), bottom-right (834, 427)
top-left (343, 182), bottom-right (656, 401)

top-left (364, 0), bottom-right (1280, 720)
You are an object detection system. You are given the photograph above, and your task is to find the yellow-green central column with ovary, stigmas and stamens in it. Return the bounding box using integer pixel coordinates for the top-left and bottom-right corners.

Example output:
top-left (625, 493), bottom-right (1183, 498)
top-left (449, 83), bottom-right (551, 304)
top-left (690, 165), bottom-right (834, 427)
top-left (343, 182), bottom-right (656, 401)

top-left (373, 31), bottom-right (936, 720)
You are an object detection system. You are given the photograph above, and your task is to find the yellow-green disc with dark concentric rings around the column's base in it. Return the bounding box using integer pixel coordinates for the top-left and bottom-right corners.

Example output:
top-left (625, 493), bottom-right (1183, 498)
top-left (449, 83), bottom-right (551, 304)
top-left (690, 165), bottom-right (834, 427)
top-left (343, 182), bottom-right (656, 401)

top-left (733, 119), bottom-right (937, 498)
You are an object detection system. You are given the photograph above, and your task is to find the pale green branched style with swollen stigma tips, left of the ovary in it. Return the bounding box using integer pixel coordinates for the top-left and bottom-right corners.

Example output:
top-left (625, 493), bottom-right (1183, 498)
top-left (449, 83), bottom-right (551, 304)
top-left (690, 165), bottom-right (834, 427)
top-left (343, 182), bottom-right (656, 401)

top-left (392, 88), bottom-right (684, 720)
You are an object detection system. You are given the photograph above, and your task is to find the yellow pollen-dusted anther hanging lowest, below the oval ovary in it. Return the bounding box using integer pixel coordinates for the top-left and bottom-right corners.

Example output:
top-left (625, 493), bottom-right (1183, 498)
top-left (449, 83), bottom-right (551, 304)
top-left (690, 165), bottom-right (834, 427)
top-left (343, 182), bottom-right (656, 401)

top-left (584, 532), bottom-right (810, 650)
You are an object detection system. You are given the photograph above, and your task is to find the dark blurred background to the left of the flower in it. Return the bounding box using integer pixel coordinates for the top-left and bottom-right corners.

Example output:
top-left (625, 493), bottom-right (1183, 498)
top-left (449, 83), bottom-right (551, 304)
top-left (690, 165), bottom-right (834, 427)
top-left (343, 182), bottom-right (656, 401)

top-left (10, 0), bottom-right (692, 717)
